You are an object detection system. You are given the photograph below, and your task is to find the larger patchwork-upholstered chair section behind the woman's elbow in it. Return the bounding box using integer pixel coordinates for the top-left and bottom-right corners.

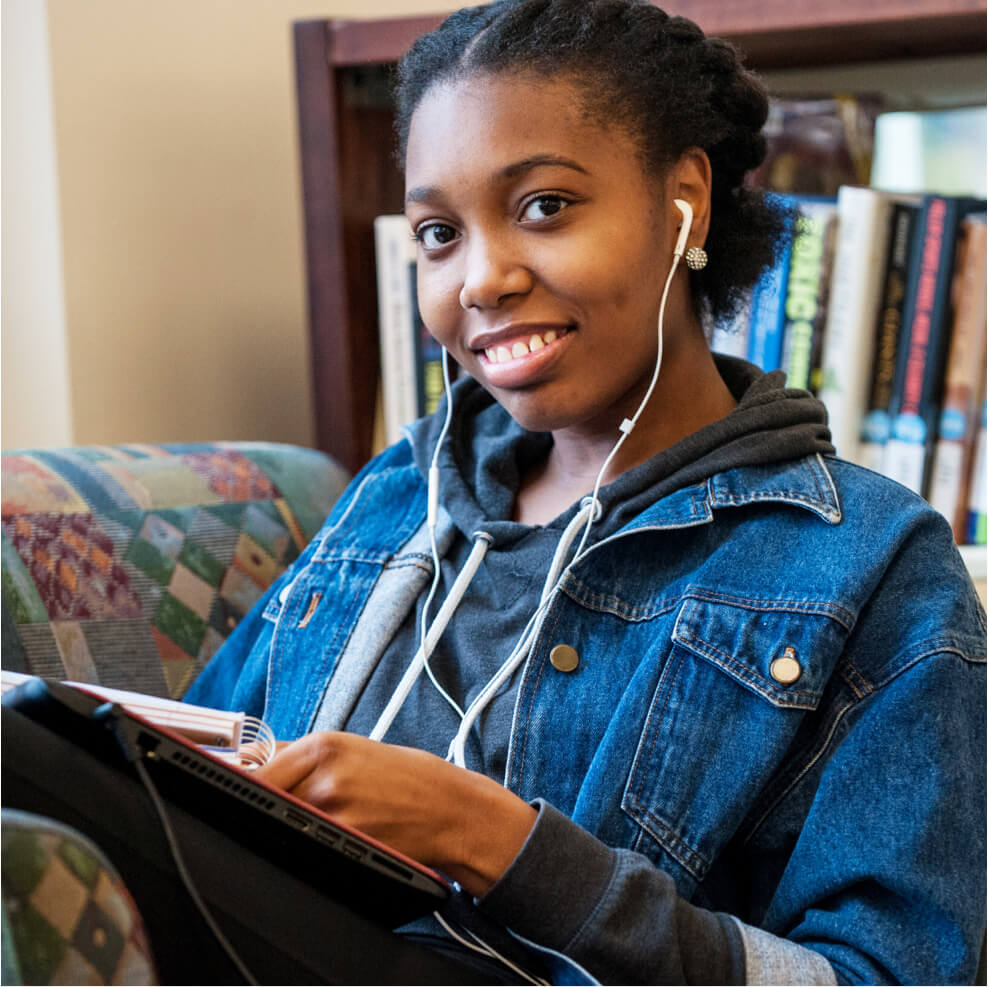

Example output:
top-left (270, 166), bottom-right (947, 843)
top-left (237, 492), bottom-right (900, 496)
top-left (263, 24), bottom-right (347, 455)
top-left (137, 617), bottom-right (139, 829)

top-left (2, 442), bottom-right (346, 698)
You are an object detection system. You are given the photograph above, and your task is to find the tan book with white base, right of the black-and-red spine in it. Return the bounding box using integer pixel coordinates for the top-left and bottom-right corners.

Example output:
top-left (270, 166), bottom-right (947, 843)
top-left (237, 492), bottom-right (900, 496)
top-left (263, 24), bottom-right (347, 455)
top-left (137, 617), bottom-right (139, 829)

top-left (928, 216), bottom-right (988, 543)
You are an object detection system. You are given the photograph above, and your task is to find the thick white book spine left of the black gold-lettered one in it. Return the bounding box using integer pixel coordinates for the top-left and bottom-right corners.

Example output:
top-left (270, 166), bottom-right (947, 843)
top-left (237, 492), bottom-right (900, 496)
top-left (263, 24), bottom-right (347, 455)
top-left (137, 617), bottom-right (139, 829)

top-left (819, 185), bottom-right (892, 462)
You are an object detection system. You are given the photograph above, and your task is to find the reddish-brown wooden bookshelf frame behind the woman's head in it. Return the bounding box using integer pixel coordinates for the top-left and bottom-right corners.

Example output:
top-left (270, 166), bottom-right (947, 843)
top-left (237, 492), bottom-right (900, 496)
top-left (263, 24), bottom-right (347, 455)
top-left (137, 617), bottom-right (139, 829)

top-left (294, 0), bottom-right (986, 471)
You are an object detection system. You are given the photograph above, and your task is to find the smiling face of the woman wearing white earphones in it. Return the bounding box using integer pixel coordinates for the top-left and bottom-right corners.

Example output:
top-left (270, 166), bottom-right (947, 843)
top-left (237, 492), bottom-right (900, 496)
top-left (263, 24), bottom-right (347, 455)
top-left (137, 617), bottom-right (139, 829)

top-left (405, 75), bottom-right (688, 433)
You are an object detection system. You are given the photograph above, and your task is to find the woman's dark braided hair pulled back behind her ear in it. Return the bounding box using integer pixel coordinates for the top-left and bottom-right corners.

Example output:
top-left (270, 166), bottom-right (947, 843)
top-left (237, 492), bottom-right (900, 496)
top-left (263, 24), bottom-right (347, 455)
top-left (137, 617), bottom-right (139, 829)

top-left (395, 0), bottom-right (791, 323)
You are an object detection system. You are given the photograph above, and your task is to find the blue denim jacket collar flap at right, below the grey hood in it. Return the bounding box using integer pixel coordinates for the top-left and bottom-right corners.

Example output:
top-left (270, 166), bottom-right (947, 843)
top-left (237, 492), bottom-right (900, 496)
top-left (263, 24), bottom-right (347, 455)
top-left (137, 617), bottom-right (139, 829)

top-left (622, 453), bottom-right (841, 531)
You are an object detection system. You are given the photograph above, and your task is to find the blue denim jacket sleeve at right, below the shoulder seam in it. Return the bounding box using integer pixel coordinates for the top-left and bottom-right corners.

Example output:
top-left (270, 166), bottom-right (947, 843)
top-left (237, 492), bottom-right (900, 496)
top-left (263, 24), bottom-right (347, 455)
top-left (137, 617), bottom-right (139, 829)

top-left (746, 641), bottom-right (986, 984)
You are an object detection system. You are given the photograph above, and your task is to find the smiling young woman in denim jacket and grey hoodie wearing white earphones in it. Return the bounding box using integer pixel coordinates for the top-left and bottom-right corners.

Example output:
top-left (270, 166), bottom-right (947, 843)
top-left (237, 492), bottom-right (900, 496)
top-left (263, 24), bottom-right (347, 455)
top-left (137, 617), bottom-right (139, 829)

top-left (189, 0), bottom-right (985, 983)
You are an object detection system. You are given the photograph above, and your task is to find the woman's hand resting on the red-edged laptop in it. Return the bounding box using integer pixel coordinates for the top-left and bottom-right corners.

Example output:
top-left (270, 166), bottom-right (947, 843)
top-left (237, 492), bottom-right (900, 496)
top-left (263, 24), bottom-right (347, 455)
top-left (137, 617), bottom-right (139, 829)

top-left (256, 732), bottom-right (537, 897)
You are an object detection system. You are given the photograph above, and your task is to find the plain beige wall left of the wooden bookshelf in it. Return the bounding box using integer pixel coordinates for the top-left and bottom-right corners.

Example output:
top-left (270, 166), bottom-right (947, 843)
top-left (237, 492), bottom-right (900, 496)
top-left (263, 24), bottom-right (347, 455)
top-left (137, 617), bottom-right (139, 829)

top-left (3, 0), bottom-right (456, 448)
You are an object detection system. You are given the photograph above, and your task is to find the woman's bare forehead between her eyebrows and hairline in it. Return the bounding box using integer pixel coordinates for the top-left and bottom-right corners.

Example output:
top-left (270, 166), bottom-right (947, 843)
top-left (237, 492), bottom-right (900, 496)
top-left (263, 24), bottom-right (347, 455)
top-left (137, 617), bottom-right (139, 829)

top-left (405, 73), bottom-right (645, 199)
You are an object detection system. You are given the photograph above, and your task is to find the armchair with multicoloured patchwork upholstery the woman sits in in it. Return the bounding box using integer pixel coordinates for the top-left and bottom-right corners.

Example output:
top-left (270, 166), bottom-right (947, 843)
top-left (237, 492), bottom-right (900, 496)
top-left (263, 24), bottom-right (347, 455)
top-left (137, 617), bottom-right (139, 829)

top-left (0, 442), bottom-right (347, 984)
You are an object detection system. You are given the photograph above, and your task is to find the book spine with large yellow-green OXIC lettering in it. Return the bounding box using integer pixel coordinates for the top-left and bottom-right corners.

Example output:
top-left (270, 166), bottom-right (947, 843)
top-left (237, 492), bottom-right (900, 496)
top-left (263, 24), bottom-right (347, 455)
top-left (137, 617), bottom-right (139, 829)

top-left (782, 202), bottom-right (837, 390)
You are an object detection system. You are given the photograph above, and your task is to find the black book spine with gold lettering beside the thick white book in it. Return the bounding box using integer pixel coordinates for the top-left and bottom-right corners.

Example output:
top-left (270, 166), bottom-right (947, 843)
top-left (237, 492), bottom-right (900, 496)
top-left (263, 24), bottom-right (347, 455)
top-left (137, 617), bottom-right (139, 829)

top-left (860, 202), bottom-right (919, 472)
